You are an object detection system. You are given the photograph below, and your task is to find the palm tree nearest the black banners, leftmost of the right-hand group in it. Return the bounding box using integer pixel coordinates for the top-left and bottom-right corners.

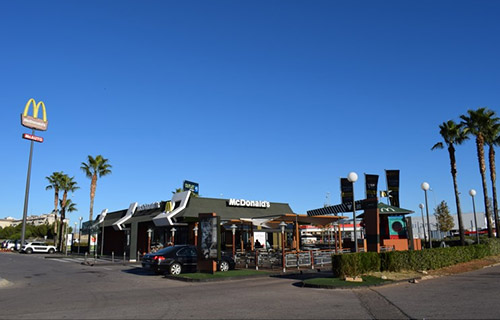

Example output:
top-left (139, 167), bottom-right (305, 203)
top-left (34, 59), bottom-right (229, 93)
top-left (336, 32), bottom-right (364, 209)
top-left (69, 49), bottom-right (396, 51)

top-left (431, 120), bottom-right (469, 246)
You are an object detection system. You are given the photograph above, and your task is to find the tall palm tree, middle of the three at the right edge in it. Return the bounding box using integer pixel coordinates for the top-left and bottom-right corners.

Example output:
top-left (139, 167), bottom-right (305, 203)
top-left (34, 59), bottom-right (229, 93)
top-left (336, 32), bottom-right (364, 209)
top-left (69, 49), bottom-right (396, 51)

top-left (460, 108), bottom-right (498, 238)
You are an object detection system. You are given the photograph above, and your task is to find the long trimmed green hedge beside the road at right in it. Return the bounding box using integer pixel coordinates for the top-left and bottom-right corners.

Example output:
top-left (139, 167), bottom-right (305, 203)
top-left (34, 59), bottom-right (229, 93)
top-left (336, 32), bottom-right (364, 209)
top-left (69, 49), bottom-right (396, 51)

top-left (332, 238), bottom-right (500, 278)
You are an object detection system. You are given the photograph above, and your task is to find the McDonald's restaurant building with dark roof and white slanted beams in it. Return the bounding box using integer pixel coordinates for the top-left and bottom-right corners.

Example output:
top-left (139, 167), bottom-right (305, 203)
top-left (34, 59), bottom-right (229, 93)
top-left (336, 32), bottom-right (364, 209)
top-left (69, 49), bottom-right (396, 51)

top-left (86, 191), bottom-right (295, 261)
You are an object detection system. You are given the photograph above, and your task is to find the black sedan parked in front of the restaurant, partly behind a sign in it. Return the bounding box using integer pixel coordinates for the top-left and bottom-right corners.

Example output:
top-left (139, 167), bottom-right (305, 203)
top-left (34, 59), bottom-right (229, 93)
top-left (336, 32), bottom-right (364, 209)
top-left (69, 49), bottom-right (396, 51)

top-left (142, 245), bottom-right (235, 275)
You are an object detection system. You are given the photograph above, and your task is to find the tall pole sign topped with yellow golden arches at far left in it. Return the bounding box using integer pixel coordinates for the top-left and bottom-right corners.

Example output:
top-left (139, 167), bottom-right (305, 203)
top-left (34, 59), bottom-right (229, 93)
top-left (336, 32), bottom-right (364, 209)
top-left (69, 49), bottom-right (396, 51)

top-left (21, 99), bottom-right (49, 245)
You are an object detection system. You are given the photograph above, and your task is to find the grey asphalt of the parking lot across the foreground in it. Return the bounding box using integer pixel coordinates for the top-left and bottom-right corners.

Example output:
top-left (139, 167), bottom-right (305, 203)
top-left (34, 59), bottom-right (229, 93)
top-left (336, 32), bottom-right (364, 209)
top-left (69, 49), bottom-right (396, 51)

top-left (0, 253), bottom-right (500, 319)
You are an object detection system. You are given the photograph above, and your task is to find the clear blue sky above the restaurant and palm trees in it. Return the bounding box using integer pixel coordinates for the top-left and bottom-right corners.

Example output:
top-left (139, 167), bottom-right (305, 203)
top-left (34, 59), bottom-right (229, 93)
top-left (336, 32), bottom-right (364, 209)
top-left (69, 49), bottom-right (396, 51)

top-left (0, 0), bottom-right (500, 224)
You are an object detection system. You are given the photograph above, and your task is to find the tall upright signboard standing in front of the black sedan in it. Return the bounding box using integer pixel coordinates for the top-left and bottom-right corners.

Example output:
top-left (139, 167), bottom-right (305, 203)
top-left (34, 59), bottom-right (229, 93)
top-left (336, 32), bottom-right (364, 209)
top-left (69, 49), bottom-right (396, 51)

top-left (199, 213), bottom-right (220, 260)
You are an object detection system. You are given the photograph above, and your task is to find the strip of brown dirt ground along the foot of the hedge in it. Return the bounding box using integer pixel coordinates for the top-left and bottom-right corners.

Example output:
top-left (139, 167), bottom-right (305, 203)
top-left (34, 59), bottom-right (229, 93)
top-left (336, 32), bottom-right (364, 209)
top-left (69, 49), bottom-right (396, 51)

top-left (370, 256), bottom-right (500, 280)
